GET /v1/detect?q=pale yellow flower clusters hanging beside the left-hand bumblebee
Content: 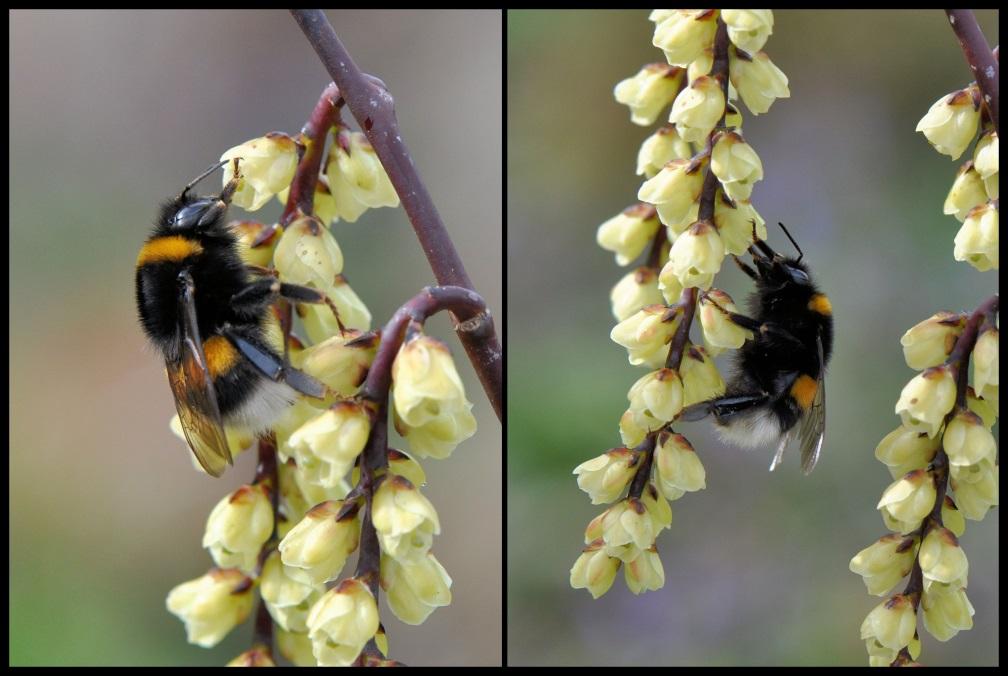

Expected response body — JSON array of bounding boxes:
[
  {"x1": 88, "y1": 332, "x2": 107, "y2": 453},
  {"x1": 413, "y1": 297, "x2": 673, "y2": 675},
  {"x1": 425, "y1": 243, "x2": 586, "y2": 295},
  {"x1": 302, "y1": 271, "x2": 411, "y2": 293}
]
[{"x1": 167, "y1": 90, "x2": 476, "y2": 666}]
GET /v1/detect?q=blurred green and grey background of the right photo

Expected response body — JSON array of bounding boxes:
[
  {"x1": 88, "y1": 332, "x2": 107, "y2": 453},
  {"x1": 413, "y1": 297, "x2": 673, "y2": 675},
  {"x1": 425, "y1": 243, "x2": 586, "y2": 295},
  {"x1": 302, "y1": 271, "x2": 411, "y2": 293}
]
[{"x1": 507, "y1": 10, "x2": 999, "y2": 665}]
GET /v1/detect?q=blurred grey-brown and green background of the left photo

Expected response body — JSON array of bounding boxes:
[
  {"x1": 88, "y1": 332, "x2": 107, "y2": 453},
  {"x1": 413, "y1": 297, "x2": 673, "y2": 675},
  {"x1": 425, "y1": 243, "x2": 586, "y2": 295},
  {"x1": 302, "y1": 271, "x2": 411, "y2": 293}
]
[{"x1": 8, "y1": 11, "x2": 504, "y2": 665}]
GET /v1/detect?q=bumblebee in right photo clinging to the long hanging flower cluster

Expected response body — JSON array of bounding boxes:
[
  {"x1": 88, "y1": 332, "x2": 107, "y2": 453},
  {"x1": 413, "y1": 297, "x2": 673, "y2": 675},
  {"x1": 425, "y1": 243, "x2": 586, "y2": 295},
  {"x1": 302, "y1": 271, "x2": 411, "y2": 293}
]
[{"x1": 680, "y1": 224, "x2": 833, "y2": 475}]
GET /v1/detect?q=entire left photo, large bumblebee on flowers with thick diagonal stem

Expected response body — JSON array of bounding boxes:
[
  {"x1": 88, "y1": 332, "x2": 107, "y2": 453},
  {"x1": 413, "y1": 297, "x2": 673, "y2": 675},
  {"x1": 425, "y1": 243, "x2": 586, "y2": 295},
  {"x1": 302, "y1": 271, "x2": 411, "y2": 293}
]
[{"x1": 8, "y1": 10, "x2": 506, "y2": 666}]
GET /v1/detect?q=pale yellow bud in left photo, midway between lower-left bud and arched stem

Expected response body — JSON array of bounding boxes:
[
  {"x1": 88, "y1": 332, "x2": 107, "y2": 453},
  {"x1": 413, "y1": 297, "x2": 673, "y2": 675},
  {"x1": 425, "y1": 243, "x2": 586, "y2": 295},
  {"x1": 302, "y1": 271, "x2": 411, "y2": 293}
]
[{"x1": 277, "y1": 501, "x2": 360, "y2": 586}]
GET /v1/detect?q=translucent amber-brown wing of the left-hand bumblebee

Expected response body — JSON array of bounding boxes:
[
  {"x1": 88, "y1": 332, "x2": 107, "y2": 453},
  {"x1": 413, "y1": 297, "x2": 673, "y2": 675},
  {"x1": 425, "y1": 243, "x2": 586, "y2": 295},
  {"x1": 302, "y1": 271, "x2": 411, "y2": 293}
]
[{"x1": 165, "y1": 275, "x2": 233, "y2": 477}]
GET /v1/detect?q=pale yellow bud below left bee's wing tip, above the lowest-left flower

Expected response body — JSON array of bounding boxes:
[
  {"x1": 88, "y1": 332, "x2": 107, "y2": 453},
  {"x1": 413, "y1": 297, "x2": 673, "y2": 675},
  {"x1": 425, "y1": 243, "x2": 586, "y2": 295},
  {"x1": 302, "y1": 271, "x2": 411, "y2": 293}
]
[{"x1": 203, "y1": 484, "x2": 273, "y2": 573}]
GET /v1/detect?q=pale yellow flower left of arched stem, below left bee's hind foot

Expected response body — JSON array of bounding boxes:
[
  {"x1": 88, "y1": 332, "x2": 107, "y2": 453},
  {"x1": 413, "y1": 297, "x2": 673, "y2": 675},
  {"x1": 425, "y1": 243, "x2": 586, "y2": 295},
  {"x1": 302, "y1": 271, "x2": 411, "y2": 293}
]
[{"x1": 289, "y1": 400, "x2": 371, "y2": 487}]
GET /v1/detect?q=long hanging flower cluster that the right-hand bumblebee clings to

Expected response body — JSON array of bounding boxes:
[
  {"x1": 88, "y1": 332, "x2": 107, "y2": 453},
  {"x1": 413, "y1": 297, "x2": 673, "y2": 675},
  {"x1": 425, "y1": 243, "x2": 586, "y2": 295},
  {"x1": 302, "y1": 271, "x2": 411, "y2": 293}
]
[{"x1": 571, "y1": 9, "x2": 790, "y2": 597}]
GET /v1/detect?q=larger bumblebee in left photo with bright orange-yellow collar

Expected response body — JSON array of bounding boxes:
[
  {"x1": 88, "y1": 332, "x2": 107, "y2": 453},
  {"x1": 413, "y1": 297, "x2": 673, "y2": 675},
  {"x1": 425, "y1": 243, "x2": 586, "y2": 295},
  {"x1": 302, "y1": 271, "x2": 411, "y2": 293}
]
[{"x1": 136, "y1": 159, "x2": 329, "y2": 477}]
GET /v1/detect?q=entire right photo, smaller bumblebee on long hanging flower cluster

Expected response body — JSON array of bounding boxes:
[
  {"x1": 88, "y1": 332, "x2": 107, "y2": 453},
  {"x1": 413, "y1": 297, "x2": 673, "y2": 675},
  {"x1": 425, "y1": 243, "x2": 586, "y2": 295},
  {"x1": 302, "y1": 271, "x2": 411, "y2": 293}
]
[{"x1": 505, "y1": 9, "x2": 1000, "y2": 666}]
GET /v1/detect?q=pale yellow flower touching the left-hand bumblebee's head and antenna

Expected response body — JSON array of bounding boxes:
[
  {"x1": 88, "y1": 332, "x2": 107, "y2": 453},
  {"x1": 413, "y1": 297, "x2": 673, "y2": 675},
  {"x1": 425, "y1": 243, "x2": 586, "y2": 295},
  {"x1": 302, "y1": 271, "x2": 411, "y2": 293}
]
[{"x1": 221, "y1": 132, "x2": 297, "y2": 212}]
